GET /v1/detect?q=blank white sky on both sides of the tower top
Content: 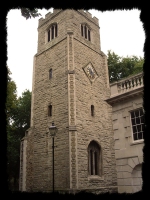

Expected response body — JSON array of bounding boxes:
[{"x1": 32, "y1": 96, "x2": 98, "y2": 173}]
[{"x1": 7, "y1": 9, "x2": 145, "y2": 96}]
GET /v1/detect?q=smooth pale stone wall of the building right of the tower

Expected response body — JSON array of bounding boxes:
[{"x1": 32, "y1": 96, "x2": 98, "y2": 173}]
[{"x1": 112, "y1": 95, "x2": 144, "y2": 193}]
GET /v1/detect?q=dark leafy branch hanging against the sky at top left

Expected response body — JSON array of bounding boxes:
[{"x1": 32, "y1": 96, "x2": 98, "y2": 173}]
[{"x1": 21, "y1": 8, "x2": 41, "y2": 19}]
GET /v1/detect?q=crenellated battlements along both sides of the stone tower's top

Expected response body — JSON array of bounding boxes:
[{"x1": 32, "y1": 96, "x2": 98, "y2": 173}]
[{"x1": 39, "y1": 9, "x2": 99, "y2": 27}]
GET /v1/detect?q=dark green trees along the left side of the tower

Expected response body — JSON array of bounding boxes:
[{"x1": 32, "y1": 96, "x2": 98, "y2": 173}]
[{"x1": 6, "y1": 66, "x2": 31, "y2": 190}]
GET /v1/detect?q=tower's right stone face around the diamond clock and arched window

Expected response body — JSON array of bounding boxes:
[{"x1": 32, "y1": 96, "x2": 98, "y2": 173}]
[{"x1": 74, "y1": 40, "x2": 117, "y2": 189}]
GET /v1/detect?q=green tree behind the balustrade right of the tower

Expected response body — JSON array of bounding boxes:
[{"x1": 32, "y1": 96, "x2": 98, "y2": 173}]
[{"x1": 107, "y1": 50, "x2": 144, "y2": 83}]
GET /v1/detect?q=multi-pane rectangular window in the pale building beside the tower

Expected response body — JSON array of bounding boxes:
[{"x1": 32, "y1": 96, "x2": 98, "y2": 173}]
[{"x1": 129, "y1": 107, "x2": 144, "y2": 142}]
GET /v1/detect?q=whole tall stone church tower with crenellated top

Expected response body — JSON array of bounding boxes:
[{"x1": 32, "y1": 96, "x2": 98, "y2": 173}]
[{"x1": 20, "y1": 9, "x2": 117, "y2": 192}]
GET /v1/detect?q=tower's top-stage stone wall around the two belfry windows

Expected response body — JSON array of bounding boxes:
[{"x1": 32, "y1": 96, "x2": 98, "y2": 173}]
[{"x1": 37, "y1": 10, "x2": 100, "y2": 53}]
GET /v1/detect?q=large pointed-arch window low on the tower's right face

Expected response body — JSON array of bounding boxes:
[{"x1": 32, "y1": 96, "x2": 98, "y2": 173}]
[{"x1": 88, "y1": 141, "x2": 102, "y2": 176}]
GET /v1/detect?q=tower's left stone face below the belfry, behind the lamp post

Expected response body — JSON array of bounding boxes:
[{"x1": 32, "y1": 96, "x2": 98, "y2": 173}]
[{"x1": 30, "y1": 36, "x2": 69, "y2": 191}]
